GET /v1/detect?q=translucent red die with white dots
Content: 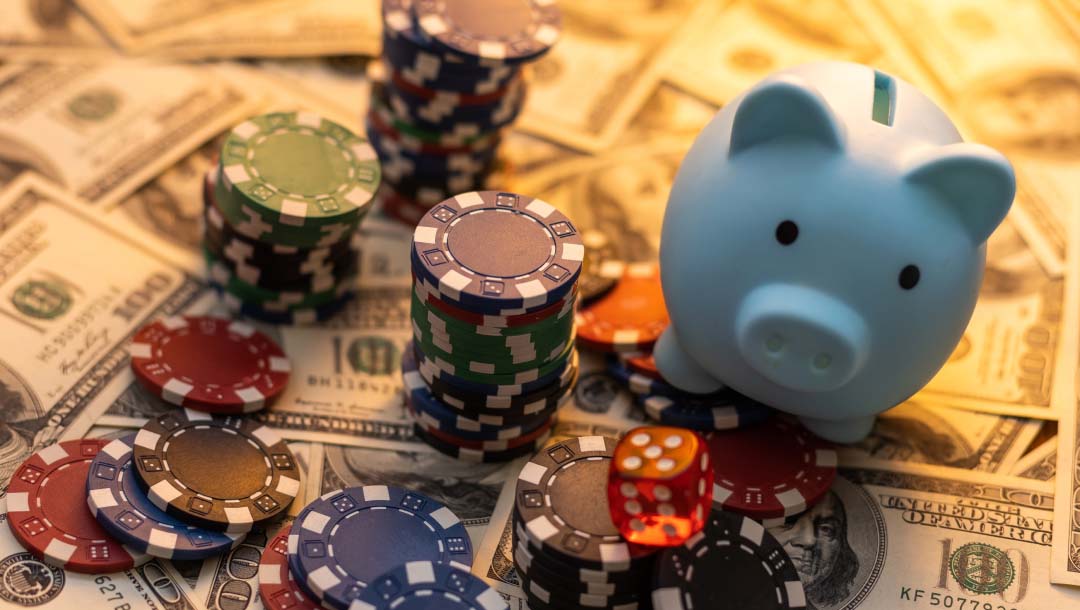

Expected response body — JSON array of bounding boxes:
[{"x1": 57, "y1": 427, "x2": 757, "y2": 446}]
[{"x1": 608, "y1": 425, "x2": 713, "y2": 546}]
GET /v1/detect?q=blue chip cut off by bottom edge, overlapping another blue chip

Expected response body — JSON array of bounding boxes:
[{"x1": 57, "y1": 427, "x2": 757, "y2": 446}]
[{"x1": 352, "y1": 561, "x2": 509, "y2": 610}]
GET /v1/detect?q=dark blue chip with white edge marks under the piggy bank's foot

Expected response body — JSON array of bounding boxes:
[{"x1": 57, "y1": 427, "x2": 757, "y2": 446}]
[{"x1": 642, "y1": 389, "x2": 774, "y2": 432}]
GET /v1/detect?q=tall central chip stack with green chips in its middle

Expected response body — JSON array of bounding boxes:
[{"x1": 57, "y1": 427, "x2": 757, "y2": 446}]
[{"x1": 402, "y1": 191, "x2": 584, "y2": 462}]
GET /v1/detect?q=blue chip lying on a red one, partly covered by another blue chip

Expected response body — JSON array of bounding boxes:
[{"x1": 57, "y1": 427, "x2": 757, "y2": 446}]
[{"x1": 288, "y1": 485, "x2": 472, "y2": 610}]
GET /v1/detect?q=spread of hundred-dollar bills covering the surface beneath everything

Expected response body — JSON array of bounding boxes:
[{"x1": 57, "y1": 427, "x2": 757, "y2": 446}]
[{"x1": 0, "y1": 0, "x2": 1080, "y2": 610}]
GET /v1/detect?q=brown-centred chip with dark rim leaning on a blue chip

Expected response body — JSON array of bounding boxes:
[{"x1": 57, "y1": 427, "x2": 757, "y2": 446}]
[{"x1": 134, "y1": 409, "x2": 300, "y2": 533}]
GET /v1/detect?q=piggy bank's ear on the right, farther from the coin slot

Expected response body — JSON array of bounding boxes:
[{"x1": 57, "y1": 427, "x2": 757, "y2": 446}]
[{"x1": 904, "y1": 143, "x2": 1016, "y2": 244}]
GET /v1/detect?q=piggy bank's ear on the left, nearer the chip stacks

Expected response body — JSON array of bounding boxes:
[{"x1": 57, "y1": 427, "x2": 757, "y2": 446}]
[{"x1": 729, "y1": 74, "x2": 843, "y2": 155}]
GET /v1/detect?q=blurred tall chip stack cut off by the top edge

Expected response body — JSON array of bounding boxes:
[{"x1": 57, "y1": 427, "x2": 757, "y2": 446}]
[{"x1": 367, "y1": 0, "x2": 562, "y2": 225}]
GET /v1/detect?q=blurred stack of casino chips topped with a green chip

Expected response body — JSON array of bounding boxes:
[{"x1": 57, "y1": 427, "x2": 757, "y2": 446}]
[{"x1": 203, "y1": 112, "x2": 380, "y2": 324}]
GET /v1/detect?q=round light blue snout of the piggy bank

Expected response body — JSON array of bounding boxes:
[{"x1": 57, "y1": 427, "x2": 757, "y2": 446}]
[{"x1": 735, "y1": 284, "x2": 869, "y2": 392}]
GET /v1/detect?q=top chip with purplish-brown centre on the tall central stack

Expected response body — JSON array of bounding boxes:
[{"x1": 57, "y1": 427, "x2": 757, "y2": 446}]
[{"x1": 413, "y1": 191, "x2": 584, "y2": 315}]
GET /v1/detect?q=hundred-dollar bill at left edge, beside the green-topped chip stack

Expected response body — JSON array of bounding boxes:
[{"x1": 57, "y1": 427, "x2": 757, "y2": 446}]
[{"x1": 0, "y1": 175, "x2": 204, "y2": 492}]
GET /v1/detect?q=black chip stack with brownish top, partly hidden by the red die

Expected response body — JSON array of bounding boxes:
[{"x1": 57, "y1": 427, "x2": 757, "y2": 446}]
[{"x1": 512, "y1": 436, "x2": 656, "y2": 610}]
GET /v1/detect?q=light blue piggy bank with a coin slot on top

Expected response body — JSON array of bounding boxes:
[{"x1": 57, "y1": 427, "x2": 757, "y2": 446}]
[{"x1": 654, "y1": 62, "x2": 1016, "y2": 443}]
